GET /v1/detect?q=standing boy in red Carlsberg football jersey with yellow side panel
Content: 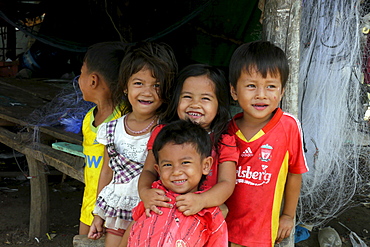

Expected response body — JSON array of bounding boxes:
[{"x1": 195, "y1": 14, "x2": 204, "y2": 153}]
[{"x1": 226, "y1": 41, "x2": 308, "y2": 247}]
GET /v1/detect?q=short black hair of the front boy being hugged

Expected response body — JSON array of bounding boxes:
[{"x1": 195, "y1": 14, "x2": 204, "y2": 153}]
[{"x1": 152, "y1": 120, "x2": 212, "y2": 164}]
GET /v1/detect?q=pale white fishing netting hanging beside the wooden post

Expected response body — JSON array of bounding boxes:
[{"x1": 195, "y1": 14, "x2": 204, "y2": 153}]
[{"x1": 298, "y1": 0, "x2": 370, "y2": 226}]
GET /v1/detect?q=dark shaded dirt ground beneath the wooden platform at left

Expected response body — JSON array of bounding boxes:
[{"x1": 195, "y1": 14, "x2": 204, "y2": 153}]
[{"x1": 0, "y1": 175, "x2": 83, "y2": 247}]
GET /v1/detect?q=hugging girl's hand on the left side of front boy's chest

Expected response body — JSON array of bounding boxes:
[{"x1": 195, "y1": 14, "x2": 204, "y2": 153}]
[{"x1": 141, "y1": 189, "x2": 173, "y2": 217}]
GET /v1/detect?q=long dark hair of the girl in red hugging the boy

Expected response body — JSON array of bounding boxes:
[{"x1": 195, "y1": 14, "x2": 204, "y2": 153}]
[{"x1": 163, "y1": 64, "x2": 231, "y2": 155}]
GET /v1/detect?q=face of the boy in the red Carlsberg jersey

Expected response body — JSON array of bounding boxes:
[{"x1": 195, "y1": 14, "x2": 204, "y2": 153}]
[{"x1": 231, "y1": 69, "x2": 284, "y2": 123}]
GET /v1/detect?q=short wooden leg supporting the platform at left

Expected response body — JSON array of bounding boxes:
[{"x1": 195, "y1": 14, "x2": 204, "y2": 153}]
[{"x1": 26, "y1": 155, "x2": 49, "y2": 239}]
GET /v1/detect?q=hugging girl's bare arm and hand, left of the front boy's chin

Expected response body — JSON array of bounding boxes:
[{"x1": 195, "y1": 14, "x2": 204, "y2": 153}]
[{"x1": 138, "y1": 150, "x2": 172, "y2": 217}]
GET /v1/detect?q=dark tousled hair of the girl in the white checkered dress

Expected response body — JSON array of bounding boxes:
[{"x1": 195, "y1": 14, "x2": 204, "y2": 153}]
[{"x1": 115, "y1": 42, "x2": 177, "y2": 116}]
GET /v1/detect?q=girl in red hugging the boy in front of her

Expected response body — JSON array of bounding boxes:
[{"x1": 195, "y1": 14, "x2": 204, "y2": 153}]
[{"x1": 139, "y1": 64, "x2": 238, "y2": 216}]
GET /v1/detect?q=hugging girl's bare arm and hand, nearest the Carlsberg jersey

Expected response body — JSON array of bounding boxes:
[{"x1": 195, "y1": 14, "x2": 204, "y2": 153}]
[{"x1": 176, "y1": 161, "x2": 236, "y2": 216}]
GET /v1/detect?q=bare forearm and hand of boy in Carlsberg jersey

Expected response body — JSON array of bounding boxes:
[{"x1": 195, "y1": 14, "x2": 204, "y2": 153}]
[{"x1": 276, "y1": 173, "x2": 302, "y2": 243}]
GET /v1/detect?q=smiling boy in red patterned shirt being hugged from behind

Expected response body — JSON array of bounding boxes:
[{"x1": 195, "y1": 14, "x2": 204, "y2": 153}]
[{"x1": 120, "y1": 120, "x2": 228, "y2": 247}]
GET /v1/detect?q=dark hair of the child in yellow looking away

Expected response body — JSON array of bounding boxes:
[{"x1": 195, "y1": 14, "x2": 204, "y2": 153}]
[{"x1": 83, "y1": 41, "x2": 129, "y2": 105}]
